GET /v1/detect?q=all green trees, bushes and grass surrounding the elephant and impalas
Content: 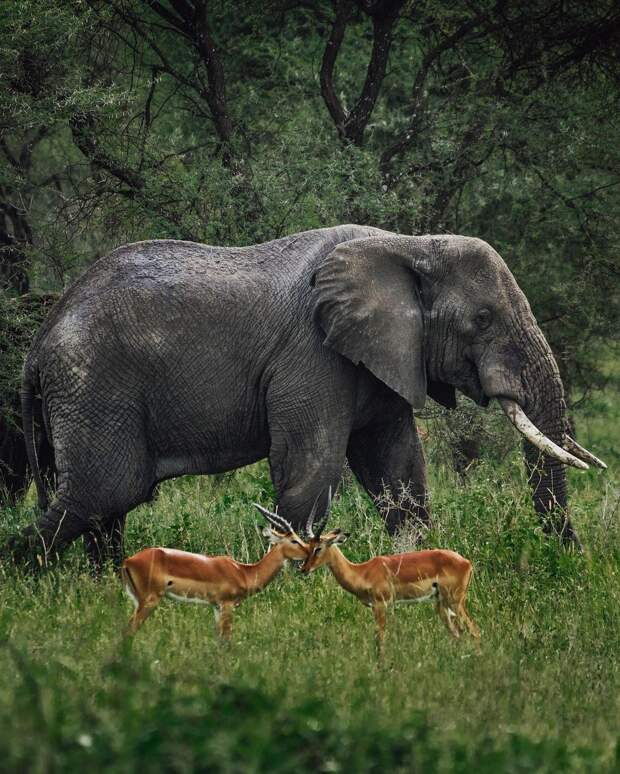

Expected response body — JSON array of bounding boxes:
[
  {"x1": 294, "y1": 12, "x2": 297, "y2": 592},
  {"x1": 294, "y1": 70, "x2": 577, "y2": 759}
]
[{"x1": 0, "y1": 0, "x2": 620, "y2": 772}]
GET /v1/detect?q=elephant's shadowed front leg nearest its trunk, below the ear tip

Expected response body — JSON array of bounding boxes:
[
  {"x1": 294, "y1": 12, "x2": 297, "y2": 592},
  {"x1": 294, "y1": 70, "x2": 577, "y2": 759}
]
[{"x1": 347, "y1": 396, "x2": 430, "y2": 534}]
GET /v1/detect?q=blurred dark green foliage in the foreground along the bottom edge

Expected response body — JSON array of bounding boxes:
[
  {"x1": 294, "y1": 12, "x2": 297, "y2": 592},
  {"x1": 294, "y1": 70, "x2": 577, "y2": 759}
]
[{"x1": 0, "y1": 660, "x2": 612, "y2": 774}]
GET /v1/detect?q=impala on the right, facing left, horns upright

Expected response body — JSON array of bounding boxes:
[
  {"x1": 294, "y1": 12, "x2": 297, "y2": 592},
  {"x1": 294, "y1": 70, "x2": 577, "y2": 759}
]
[{"x1": 301, "y1": 490, "x2": 480, "y2": 655}]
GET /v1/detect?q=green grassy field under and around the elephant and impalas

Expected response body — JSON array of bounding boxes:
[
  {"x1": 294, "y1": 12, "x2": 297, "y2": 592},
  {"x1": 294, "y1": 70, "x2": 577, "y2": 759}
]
[{"x1": 0, "y1": 396, "x2": 620, "y2": 774}]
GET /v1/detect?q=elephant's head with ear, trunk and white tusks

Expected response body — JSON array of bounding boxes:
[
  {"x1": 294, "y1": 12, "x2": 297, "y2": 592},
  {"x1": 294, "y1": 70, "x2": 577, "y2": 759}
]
[{"x1": 315, "y1": 233, "x2": 603, "y2": 536}]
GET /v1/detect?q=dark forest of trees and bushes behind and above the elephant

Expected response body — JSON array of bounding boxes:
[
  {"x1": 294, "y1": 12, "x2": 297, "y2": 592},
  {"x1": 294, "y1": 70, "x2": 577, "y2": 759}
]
[{"x1": 0, "y1": 0, "x2": 620, "y2": 498}]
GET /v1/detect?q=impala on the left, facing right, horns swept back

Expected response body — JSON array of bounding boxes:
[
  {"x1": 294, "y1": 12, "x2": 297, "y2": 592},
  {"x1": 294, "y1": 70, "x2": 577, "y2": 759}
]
[{"x1": 121, "y1": 503, "x2": 306, "y2": 640}]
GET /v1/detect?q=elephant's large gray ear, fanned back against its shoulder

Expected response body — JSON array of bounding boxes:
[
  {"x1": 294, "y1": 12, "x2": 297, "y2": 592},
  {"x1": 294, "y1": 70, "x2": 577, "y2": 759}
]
[{"x1": 314, "y1": 238, "x2": 426, "y2": 409}]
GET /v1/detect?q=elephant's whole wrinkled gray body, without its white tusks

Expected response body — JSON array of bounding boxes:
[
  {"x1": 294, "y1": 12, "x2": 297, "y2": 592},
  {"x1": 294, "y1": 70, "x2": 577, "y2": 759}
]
[{"x1": 11, "y1": 225, "x2": 573, "y2": 561}]
